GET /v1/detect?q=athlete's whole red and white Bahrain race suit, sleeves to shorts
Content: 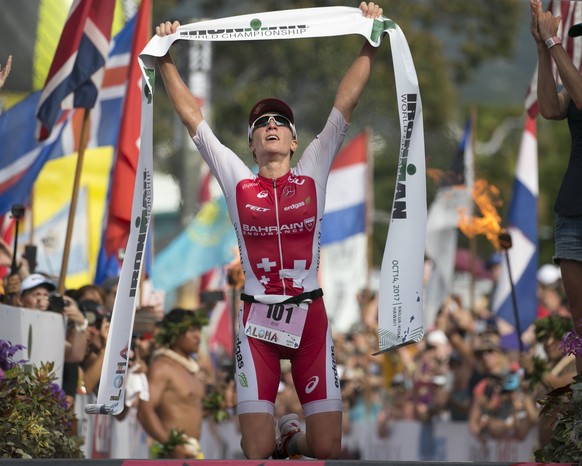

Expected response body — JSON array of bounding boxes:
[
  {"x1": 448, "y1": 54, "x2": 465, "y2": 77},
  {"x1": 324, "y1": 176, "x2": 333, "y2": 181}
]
[{"x1": 193, "y1": 108, "x2": 349, "y2": 416}]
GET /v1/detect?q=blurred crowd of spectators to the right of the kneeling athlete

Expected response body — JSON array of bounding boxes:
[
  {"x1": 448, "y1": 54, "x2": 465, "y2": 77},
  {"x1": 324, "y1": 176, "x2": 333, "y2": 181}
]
[{"x1": 336, "y1": 265, "x2": 576, "y2": 459}]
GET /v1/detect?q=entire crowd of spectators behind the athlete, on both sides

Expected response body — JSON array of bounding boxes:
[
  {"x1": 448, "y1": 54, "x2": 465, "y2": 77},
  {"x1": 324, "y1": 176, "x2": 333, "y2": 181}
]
[{"x1": 3, "y1": 256, "x2": 576, "y2": 458}]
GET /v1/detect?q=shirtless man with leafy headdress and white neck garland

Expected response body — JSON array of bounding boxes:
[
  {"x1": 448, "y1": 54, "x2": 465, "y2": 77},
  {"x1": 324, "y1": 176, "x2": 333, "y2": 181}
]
[{"x1": 138, "y1": 309, "x2": 208, "y2": 459}]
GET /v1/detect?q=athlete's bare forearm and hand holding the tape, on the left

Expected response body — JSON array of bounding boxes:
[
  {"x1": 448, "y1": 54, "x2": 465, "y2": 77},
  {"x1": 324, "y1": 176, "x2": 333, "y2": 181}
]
[{"x1": 156, "y1": 21, "x2": 204, "y2": 136}]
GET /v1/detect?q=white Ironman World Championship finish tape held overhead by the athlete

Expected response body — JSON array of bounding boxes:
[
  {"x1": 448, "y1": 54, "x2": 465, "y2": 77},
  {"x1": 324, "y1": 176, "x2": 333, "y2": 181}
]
[{"x1": 91, "y1": 7, "x2": 426, "y2": 414}]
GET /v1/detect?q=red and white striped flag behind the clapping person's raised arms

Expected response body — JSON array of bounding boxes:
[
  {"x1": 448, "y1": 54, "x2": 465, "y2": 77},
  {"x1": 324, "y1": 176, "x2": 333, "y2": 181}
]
[{"x1": 525, "y1": 0, "x2": 582, "y2": 118}]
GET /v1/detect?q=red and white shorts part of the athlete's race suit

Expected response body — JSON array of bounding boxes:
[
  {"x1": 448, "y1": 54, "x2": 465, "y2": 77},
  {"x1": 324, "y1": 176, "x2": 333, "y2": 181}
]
[{"x1": 235, "y1": 298, "x2": 342, "y2": 416}]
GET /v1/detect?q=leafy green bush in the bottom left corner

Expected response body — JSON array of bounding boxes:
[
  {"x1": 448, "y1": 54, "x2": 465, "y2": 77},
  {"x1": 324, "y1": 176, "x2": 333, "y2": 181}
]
[{"x1": 0, "y1": 340, "x2": 83, "y2": 458}]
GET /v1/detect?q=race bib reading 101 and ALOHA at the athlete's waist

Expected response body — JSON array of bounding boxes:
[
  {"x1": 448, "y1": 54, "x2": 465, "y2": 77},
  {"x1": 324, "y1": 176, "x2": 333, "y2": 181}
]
[{"x1": 245, "y1": 303, "x2": 307, "y2": 349}]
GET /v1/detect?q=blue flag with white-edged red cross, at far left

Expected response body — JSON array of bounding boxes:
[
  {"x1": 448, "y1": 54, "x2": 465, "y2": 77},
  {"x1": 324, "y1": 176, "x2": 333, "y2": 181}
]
[{"x1": 0, "y1": 18, "x2": 135, "y2": 219}]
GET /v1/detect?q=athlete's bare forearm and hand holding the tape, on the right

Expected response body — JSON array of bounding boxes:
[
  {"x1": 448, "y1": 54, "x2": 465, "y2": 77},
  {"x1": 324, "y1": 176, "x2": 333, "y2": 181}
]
[{"x1": 334, "y1": 2, "x2": 383, "y2": 121}]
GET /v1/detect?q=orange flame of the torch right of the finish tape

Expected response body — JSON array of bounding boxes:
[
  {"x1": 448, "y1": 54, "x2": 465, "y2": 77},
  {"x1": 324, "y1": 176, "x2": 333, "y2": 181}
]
[{"x1": 459, "y1": 180, "x2": 505, "y2": 250}]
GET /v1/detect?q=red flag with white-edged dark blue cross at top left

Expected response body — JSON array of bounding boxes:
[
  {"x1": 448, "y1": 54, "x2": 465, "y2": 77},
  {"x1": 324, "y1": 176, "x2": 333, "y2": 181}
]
[{"x1": 36, "y1": 0, "x2": 115, "y2": 141}]
